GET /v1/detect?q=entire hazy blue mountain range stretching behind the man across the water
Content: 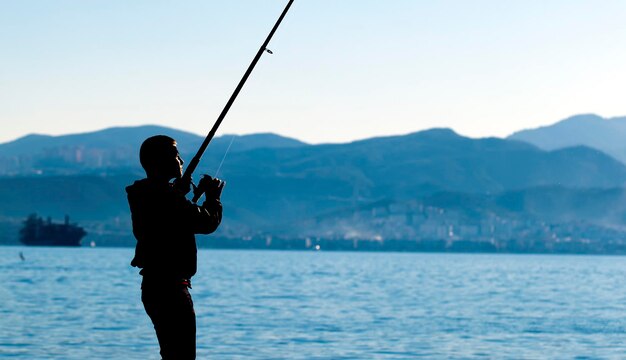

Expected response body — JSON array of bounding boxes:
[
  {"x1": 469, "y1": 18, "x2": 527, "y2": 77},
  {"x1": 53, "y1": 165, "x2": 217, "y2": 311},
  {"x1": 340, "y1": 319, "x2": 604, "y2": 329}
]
[{"x1": 0, "y1": 116, "x2": 626, "y2": 249}]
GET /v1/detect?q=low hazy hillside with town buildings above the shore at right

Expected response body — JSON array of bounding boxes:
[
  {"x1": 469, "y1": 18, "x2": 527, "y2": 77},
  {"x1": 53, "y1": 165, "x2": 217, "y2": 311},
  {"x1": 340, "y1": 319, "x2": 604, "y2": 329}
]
[{"x1": 302, "y1": 186, "x2": 626, "y2": 243}]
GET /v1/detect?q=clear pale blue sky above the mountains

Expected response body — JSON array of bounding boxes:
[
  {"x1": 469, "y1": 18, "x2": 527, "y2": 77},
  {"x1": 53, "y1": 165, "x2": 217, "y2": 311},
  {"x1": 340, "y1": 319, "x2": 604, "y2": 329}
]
[{"x1": 0, "y1": 0, "x2": 626, "y2": 143}]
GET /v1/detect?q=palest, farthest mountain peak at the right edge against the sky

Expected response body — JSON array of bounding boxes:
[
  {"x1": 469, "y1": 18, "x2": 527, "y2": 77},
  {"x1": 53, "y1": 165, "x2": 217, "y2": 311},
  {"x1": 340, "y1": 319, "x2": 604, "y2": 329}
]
[{"x1": 508, "y1": 114, "x2": 626, "y2": 163}]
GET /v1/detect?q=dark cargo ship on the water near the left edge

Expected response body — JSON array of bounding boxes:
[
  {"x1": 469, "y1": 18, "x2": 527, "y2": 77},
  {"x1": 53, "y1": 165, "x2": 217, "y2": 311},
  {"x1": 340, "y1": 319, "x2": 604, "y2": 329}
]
[{"x1": 20, "y1": 214, "x2": 87, "y2": 246}]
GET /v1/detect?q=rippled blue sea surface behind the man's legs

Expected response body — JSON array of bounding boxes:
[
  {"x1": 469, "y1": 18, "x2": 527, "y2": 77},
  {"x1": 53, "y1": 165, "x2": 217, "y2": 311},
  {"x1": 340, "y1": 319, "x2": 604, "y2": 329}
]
[{"x1": 0, "y1": 247, "x2": 626, "y2": 359}]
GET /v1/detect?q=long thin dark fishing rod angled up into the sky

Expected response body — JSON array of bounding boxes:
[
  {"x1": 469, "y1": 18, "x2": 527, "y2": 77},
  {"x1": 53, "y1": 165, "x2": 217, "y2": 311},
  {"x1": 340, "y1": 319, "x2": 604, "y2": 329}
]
[{"x1": 176, "y1": 0, "x2": 294, "y2": 202}]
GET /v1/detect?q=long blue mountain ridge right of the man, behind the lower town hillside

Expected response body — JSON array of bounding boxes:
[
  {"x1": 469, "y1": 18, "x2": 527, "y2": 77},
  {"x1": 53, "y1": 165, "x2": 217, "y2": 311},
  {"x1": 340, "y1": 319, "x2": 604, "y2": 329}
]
[{"x1": 224, "y1": 129, "x2": 626, "y2": 199}]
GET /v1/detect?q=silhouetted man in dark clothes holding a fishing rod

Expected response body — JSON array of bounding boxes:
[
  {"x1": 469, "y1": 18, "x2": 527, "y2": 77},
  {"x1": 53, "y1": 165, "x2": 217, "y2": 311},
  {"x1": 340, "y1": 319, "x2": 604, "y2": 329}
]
[{"x1": 126, "y1": 135, "x2": 224, "y2": 360}]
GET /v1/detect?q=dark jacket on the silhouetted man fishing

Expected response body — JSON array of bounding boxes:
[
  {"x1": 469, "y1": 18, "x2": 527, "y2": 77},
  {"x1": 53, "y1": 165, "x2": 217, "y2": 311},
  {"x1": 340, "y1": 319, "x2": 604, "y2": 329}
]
[{"x1": 126, "y1": 179, "x2": 222, "y2": 279}]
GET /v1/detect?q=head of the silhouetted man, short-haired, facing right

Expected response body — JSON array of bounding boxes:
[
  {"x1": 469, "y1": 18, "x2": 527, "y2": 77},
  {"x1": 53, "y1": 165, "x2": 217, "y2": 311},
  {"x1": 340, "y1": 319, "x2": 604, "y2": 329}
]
[{"x1": 139, "y1": 135, "x2": 183, "y2": 181}]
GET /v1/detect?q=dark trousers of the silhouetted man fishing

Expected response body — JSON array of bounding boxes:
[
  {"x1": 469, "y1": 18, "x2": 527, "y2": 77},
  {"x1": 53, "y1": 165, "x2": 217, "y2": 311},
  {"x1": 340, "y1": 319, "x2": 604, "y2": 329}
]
[{"x1": 141, "y1": 278, "x2": 196, "y2": 360}]
